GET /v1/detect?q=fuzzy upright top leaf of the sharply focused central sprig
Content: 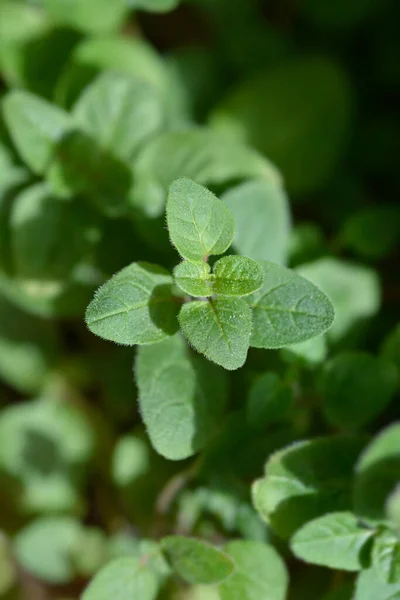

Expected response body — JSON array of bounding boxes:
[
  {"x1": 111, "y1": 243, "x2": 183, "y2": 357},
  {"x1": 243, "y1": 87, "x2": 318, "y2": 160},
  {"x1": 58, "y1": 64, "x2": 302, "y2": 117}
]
[{"x1": 167, "y1": 179, "x2": 235, "y2": 261}]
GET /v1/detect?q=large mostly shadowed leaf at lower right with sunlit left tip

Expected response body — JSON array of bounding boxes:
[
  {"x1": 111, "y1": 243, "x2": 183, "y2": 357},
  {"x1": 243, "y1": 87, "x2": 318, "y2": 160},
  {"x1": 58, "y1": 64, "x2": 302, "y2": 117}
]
[{"x1": 253, "y1": 437, "x2": 363, "y2": 539}]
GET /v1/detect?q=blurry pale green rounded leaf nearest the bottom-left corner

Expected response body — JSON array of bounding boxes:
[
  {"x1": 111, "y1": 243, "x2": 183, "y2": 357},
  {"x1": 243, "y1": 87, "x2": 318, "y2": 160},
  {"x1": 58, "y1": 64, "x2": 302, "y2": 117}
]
[{"x1": 14, "y1": 517, "x2": 81, "y2": 585}]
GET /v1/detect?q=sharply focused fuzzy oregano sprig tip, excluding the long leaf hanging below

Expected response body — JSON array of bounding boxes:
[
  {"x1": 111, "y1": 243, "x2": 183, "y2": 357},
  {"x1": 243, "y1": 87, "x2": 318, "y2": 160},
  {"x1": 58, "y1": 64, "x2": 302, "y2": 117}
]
[{"x1": 86, "y1": 179, "x2": 334, "y2": 370}]
